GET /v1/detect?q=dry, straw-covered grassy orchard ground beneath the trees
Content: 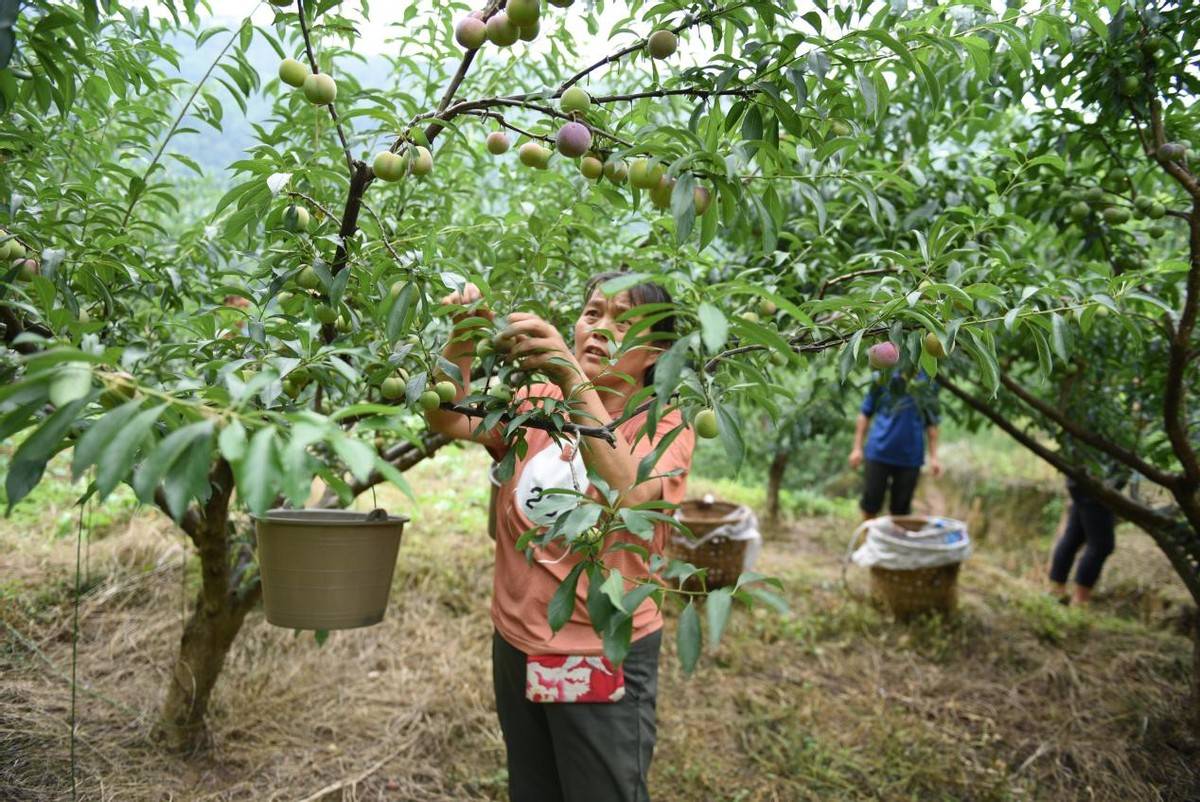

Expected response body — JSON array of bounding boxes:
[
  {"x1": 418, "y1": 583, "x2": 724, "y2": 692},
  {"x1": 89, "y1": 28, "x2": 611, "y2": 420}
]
[{"x1": 0, "y1": 437, "x2": 1200, "y2": 802}]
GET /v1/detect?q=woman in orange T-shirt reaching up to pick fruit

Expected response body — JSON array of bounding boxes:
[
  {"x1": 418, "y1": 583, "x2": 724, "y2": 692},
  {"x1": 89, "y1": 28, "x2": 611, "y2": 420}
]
[{"x1": 426, "y1": 273, "x2": 695, "y2": 802}]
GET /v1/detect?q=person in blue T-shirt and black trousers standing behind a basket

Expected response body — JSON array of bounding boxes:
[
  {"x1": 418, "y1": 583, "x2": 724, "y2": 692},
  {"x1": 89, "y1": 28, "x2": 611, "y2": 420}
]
[{"x1": 850, "y1": 372, "x2": 942, "y2": 519}]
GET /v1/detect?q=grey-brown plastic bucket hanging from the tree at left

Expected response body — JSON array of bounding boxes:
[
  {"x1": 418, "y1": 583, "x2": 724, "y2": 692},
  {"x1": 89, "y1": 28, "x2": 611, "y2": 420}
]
[{"x1": 254, "y1": 509, "x2": 408, "y2": 629}]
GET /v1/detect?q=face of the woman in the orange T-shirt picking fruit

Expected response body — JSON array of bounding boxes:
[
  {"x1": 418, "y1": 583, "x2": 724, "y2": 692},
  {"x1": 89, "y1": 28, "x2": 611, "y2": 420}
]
[{"x1": 575, "y1": 289, "x2": 659, "y2": 387}]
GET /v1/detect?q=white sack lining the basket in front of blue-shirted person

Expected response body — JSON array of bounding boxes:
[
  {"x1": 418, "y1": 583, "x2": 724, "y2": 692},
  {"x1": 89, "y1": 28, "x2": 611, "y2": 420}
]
[{"x1": 851, "y1": 515, "x2": 971, "y2": 570}]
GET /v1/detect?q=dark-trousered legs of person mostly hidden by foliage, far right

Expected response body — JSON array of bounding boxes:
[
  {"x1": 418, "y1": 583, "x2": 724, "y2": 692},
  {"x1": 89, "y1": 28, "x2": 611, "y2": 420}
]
[{"x1": 1050, "y1": 479, "x2": 1116, "y2": 605}]
